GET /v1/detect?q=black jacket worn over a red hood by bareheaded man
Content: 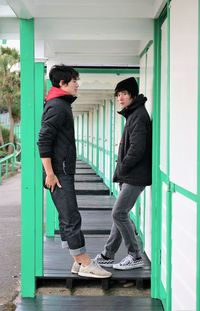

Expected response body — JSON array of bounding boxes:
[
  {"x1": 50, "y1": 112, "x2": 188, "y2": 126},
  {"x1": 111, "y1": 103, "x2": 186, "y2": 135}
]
[{"x1": 38, "y1": 95, "x2": 76, "y2": 174}]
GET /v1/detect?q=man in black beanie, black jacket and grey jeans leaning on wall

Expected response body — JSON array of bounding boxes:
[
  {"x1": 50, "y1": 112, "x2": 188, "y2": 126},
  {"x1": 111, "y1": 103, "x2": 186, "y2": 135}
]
[{"x1": 95, "y1": 78, "x2": 152, "y2": 270}]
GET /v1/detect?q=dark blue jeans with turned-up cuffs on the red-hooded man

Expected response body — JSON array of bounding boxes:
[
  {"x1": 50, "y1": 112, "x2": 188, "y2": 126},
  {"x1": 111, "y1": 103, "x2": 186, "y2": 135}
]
[{"x1": 51, "y1": 174, "x2": 86, "y2": 256}]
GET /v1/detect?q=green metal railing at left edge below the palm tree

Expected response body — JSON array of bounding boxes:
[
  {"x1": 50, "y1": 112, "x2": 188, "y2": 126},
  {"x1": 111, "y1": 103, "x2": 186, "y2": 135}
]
[{"x1": 0, "y1": 143, "x2": 16, "y2": 185}]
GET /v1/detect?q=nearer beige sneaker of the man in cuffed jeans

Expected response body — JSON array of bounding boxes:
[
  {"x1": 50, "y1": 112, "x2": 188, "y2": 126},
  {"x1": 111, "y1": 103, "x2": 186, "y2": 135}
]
[{"x1": 78, "y1": 260, "x2": 112, "y2": 279}]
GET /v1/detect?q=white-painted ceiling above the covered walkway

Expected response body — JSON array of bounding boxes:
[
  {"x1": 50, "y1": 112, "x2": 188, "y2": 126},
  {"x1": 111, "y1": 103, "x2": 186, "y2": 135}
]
[{"x1": 0, "y1": 0, "x2": 166, "y2": 112}]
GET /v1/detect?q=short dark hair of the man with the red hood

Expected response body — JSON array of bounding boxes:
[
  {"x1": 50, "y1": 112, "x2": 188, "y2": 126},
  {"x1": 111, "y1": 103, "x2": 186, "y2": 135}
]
[{"x1": 49, "y1": 65, "x2": 79, "y2": 88}]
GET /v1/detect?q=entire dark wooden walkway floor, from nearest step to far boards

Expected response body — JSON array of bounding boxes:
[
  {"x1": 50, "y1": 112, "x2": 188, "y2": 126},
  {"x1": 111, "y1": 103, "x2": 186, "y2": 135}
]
[{"x1": 16, "y1": 161, "x2": 163, "y2": 311}]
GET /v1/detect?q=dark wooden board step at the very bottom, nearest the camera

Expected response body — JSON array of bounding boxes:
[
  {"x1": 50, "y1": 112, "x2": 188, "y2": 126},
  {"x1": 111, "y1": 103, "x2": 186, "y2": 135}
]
[{"x1": 16, "y1": 296, "x2": 163, "y2": 311}]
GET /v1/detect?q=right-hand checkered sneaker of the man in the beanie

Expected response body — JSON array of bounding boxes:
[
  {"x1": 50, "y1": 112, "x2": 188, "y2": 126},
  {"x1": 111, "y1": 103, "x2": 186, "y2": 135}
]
[{"x1": 113, "y1": 255, "x2": 144, "y2": 270}]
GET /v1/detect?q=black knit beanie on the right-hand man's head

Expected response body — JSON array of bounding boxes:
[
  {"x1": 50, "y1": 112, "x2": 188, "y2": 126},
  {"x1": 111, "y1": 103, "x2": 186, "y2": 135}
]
[{"x1": 115, "y1": 77, "x2": 139, "y2": 98}]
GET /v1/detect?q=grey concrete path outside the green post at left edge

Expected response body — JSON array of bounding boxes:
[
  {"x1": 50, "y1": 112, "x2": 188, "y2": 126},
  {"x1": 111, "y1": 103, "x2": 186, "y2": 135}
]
[{"x1": 0, "y1": 173, "x2": 21, "y2": 310}]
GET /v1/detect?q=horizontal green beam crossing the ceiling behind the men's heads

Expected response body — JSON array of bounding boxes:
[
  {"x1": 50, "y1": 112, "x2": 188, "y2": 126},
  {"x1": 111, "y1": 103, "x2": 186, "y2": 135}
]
[{"x1": 74, "y1": 66, "x2": 140, "y2": 75}]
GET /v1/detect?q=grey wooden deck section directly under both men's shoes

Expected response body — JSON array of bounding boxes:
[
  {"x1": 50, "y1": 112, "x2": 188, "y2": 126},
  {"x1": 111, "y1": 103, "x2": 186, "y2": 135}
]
[{"x1": 42, "y1": 235, "x2": 151, "y2": 280}]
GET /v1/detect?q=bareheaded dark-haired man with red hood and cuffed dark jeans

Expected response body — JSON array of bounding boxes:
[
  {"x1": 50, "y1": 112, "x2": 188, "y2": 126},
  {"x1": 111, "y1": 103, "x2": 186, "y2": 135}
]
[{"x1": 38, "y1": 65, "x2": 111, "y2": 278}]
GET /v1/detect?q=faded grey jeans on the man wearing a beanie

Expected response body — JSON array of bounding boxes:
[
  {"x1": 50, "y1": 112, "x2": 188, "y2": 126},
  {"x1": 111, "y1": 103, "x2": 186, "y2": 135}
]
[{"x1": 102, "y1": 183, "x2": 145, "y2": 259}]
